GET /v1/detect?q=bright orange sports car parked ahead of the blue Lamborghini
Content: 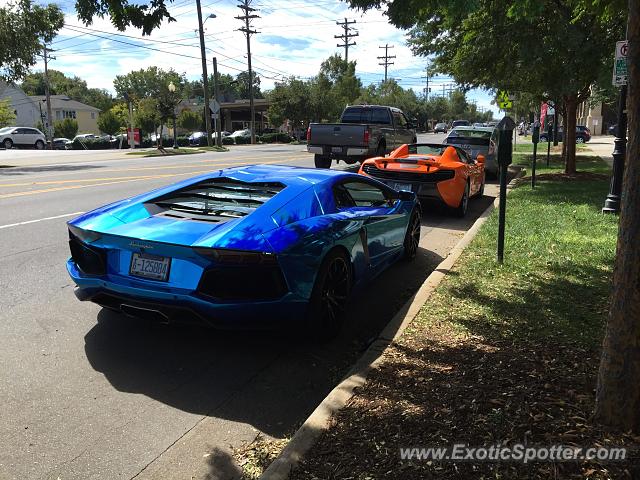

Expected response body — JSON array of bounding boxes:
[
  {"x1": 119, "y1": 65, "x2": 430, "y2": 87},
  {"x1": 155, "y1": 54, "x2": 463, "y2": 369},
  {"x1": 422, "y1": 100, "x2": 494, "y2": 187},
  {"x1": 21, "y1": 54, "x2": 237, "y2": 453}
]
[{"x1": 359, "y1": 143, "x2": 485, "y2": 217}]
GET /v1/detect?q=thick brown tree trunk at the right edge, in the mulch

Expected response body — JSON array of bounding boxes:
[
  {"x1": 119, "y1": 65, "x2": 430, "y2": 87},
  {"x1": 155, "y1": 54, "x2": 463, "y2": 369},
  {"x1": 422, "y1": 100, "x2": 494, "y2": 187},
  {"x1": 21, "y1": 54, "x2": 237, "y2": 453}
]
[{"x1": 595, "y1": 0, "x2": 640, "y2": 433}]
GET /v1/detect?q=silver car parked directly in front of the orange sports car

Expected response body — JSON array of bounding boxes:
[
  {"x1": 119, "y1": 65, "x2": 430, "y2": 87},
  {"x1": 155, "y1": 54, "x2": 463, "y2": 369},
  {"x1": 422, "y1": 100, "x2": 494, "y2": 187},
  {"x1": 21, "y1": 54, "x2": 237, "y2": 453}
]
[{"x1": 442, "y1": 127, "x2": 498, "y2": 178}]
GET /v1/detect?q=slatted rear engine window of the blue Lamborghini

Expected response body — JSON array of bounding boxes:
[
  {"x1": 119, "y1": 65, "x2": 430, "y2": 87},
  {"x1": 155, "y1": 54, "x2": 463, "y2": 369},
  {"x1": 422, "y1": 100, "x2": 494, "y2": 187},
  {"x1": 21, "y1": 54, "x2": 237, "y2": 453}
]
[{"x1": 151, "y1": 178, "x2": 285, "y2": 220}]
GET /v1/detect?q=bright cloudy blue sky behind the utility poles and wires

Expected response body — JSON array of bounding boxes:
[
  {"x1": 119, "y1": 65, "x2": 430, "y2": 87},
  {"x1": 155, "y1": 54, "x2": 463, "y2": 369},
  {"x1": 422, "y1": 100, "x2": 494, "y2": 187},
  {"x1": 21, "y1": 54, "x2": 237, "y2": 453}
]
[{"x1": 15, "y1": 0, "x2": 497, "y2": 116}]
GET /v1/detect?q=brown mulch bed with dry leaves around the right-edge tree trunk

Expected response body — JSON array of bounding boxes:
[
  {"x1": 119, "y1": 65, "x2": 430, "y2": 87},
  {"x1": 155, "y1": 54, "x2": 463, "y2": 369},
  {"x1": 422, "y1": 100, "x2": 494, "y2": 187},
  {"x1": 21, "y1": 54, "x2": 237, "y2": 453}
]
[{"x1": 291, "y1": 318, "x2": 640, "y2": 480}]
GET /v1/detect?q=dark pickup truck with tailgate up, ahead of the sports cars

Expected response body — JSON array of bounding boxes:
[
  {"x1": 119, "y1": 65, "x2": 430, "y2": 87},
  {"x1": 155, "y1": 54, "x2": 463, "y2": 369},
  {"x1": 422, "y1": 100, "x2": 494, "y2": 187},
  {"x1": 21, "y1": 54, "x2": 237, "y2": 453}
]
[{"x1": 307, "y1": 105, "x2": 416, "y2": 168}]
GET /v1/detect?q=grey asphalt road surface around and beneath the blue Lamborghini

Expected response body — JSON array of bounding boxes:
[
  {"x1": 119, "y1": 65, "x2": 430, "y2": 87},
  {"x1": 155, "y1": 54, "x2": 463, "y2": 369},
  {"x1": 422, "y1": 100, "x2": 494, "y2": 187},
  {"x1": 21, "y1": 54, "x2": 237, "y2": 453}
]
[{"x1": 0, "y1": 135, "x2": 496, "y2": 480}]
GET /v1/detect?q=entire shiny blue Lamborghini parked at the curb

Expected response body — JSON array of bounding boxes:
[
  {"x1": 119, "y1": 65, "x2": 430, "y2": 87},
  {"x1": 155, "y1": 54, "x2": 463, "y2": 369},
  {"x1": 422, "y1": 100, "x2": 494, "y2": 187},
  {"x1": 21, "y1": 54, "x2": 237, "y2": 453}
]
[{"x1": 67, "y1": 165, "x2": 420, "y2": 337}]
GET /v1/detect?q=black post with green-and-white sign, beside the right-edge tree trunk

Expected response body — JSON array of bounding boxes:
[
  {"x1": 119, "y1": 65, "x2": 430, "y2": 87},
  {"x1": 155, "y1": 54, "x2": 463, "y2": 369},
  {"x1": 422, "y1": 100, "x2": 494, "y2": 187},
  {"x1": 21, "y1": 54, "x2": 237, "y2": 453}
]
[{"x1": 602, "y1": 40, "x2": 629, "y2": 213}]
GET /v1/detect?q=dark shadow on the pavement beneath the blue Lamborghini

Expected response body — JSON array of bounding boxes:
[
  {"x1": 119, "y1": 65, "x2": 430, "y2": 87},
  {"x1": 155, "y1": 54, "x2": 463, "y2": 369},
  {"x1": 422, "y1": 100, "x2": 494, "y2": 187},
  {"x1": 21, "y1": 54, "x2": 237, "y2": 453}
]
[{"x1": 85, "y1": 244, "x2": 442, "y2": 438}]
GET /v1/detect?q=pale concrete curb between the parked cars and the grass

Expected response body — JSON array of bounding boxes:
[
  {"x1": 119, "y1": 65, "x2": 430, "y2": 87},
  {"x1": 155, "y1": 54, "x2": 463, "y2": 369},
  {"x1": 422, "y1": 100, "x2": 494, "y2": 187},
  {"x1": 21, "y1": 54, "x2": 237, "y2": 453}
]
[{"x1": 259, "y1": 169, "x2": 524, "y2": 480}]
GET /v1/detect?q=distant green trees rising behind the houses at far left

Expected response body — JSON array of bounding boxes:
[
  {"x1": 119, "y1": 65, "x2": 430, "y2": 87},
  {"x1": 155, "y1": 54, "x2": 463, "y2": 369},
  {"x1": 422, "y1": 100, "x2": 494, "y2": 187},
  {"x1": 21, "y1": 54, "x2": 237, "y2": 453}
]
[{"x1": 20, "y1": 70, "x2": 114, "y2": 112}]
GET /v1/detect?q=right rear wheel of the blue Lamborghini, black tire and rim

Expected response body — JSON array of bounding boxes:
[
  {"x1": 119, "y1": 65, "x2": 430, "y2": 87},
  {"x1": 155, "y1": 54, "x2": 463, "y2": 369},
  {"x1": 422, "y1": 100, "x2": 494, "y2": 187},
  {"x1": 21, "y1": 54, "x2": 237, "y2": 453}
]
[{"x1": 307, "y1": 250, "x2": 351, "y2": 342}]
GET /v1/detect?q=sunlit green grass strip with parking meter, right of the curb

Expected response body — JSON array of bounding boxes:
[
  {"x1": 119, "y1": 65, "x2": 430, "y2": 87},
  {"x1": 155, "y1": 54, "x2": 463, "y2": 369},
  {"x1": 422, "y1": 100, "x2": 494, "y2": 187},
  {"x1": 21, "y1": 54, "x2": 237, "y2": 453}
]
[{"x1": 412, "y1": 157, "x2": 618, "y2": 347}]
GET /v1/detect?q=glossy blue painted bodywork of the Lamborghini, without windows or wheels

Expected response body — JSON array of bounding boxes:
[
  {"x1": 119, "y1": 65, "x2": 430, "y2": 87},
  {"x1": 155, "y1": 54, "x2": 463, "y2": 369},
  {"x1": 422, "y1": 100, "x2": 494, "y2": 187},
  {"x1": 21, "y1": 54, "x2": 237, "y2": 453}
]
[{"x1": 67, "y1": 165, "x2": 417, "y2": 325}]
